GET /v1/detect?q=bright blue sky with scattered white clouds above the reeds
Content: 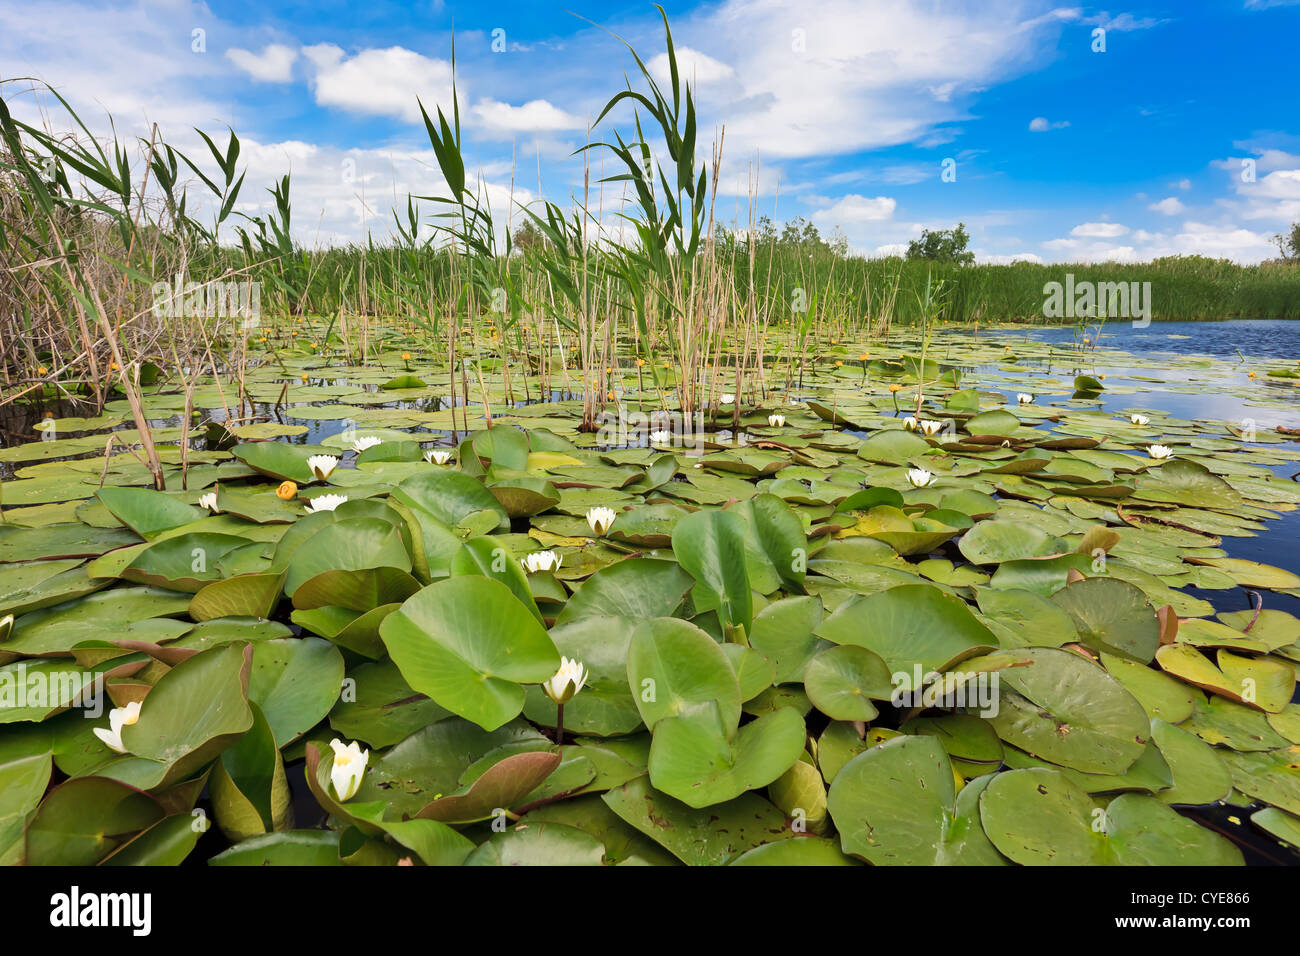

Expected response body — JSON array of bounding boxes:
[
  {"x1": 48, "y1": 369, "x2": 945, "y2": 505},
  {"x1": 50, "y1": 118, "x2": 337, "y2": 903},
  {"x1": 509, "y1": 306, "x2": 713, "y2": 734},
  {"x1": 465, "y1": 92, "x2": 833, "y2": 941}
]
[{"x1": 0, "y1": 0, "x2": 1300, "y2": 261}]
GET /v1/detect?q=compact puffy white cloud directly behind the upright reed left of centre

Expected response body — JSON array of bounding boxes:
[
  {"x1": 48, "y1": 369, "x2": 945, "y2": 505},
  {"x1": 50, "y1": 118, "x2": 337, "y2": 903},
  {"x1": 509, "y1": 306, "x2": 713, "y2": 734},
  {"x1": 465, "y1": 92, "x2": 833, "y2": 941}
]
[{"x1": 303, "y1": 43, "x2": 465, "y2": 124}]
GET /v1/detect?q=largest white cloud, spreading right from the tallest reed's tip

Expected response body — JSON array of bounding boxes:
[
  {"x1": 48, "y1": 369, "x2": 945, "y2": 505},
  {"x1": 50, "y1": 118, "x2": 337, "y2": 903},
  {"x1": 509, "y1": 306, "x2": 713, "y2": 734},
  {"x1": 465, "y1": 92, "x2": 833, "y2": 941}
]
[{"x1": 655, "y1": 0, "x2": 1078, "y2": 159}]
